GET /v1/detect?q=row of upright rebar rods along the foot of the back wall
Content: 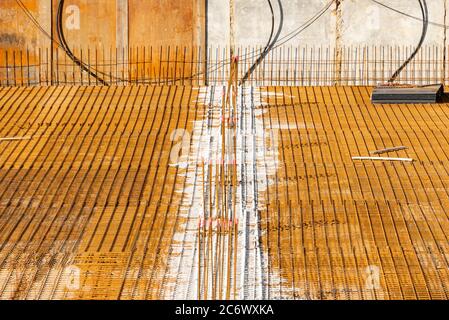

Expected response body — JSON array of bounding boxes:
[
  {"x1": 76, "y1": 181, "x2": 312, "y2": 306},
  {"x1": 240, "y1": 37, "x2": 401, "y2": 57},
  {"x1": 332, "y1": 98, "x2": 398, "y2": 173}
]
[{"x1": 0, "y1": 46, "x2": 449, "y2": 86}]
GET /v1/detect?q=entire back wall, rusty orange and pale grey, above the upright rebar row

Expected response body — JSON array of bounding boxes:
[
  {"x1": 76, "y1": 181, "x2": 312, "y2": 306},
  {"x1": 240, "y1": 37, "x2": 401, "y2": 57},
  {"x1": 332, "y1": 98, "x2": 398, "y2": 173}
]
[{"x1": 0, "y1": 0, "x2": 448, "y2": 48}]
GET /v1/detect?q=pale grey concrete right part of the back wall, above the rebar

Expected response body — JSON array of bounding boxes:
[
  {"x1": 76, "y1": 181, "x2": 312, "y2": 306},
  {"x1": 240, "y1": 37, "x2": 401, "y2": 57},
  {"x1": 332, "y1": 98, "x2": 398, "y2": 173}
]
[{"x1": 208, "y1": 0, "x2": 448, "y2": 46}]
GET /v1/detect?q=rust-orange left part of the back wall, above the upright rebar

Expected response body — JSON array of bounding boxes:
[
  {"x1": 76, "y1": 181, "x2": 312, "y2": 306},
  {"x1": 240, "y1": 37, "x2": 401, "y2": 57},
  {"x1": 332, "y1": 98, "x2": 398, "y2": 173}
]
[{"x1": 0, "y1": 0, "x2": 205, "y2": 49}]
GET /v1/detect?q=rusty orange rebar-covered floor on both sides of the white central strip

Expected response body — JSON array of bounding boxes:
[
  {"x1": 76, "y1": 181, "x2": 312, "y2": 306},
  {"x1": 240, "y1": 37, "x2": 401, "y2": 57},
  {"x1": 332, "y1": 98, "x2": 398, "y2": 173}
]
[{"x1": 0, "y1": 86, "x2": 449, "y2": 299}]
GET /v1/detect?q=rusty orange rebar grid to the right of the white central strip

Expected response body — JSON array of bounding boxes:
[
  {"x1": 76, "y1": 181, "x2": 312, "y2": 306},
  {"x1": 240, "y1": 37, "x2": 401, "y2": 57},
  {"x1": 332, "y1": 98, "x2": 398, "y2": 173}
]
[{"x1": 261, "y1": 87, "x2": 449, "y2": 299}]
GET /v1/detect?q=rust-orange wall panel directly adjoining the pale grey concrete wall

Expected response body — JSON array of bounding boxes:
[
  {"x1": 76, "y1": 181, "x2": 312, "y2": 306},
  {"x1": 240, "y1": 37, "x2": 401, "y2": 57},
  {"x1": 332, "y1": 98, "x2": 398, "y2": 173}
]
[{"x1": 128, "y1": 0, "x2": 206, "y2": 78}]
